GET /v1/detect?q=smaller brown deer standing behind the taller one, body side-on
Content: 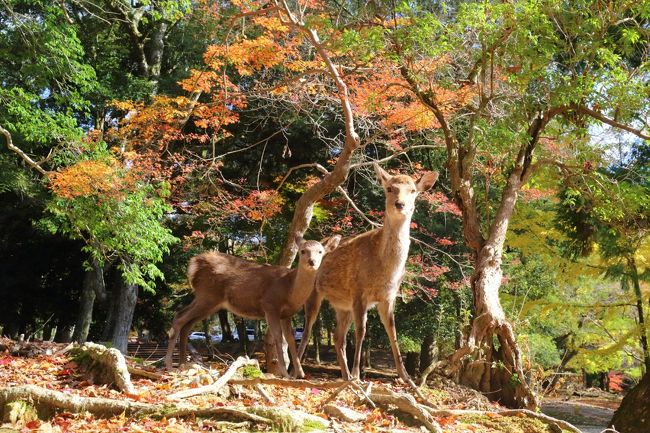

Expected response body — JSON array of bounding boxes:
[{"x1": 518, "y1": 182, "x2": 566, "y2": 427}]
[{"x1": 165, "y1": 235, "x2": 341, "y2": 378}]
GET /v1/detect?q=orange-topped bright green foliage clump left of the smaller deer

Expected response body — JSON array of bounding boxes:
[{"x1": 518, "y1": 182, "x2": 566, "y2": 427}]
[{"x1": 40, "y1": 145, "x2": 176, "y2": 290}]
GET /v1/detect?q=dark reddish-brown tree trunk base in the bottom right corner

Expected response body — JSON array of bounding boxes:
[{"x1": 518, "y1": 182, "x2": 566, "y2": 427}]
[{"x1": 611, "y1": 370, "x2": 650, "y2": 433}]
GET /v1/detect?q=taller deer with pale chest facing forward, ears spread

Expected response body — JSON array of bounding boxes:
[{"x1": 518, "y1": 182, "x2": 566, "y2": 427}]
[{"x1": 298, "y1": 164, "x2": 438, "y2": 383}]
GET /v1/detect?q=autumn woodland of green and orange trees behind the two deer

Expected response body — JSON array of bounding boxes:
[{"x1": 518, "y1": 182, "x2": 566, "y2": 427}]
[{"x1": 0, "y1": 0, "x2": 650, "y2": 420}]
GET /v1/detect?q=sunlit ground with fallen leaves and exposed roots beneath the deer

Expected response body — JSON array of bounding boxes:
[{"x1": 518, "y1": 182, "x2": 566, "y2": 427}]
[{"x1": 0, "y1": 339, "x2": 611, "y2": 433}]
